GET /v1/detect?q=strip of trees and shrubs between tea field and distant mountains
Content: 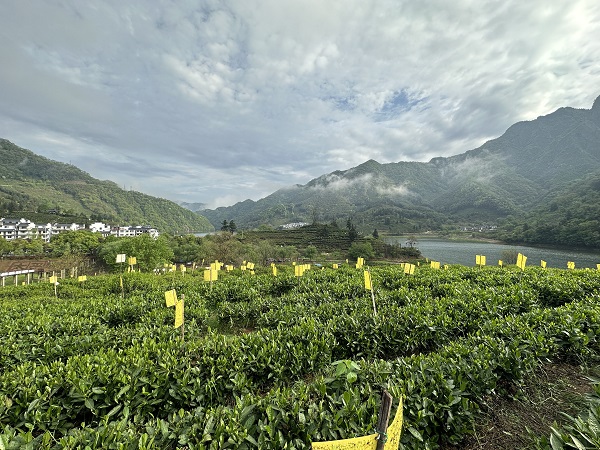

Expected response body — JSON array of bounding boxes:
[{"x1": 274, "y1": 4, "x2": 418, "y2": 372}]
[{"x1": 0, "y1": 224, "x2": 421, "y2": 271}]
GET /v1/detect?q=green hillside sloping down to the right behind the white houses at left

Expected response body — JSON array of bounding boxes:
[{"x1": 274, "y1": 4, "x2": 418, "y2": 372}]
[{"x1": 0, "y1": 139, "x2": 213, "y2": 232}]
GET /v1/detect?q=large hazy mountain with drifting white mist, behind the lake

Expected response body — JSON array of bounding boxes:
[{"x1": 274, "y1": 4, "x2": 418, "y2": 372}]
[{"x1": 199, "y1": 97, "x2": 600, "y2": 241}]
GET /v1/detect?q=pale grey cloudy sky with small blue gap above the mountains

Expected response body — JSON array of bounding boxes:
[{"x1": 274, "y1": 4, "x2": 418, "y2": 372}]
[{"x1": 0, "y1": 0, "x2": 600, "y2": 207}]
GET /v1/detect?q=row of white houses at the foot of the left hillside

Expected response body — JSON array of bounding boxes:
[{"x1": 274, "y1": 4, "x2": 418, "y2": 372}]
[{"x1": 0, "y1": 217, "x2": 158, "y2": 242}]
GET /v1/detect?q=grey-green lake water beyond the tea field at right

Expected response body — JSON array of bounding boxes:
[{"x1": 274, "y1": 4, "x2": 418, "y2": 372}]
[{"x1": 386, "y1": 236, "x2": 600, "y2": 269}]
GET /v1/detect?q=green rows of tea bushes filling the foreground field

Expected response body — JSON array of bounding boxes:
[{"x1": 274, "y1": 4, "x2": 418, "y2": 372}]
[{"x1": 0, "y1": 266, "x2": 600, "y2": 449}]
